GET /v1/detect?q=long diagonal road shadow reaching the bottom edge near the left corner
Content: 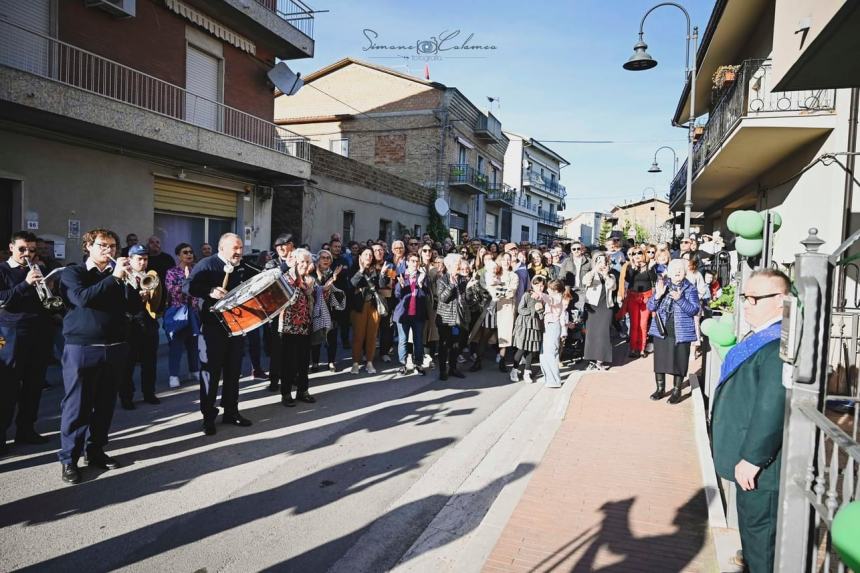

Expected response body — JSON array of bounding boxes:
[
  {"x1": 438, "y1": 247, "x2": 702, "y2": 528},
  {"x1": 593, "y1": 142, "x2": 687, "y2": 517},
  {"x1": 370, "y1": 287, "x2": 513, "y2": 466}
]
[{"x1": 16, "y1": 438, "x2": 454, "y2": 571}]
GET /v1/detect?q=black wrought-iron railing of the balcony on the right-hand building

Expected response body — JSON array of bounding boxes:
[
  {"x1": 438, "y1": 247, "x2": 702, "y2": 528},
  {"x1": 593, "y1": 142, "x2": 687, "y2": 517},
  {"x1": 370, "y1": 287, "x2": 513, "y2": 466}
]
[{"x1": 670, "y1": 59, "x2": 836, "y2": 203}]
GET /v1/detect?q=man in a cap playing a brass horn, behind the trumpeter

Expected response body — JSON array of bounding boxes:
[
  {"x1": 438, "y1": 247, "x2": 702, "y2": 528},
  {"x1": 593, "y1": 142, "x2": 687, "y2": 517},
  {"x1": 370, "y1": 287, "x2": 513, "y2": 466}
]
[{"x1": 119, "y1": 245, "x2": 162, "y2": 410}]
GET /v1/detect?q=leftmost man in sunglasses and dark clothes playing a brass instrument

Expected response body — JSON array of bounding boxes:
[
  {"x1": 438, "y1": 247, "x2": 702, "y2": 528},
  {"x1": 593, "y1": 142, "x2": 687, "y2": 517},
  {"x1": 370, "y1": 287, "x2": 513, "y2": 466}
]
[{"x1": 0, "y1": 231, "x2": 51, "y2": 455}]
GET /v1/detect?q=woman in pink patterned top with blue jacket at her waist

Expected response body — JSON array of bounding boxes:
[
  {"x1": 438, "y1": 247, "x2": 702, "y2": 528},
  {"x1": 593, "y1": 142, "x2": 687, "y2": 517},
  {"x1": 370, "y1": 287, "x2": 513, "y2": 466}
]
[{"x1": 163, "y1": 243, "x2": 200, "y2": 388}]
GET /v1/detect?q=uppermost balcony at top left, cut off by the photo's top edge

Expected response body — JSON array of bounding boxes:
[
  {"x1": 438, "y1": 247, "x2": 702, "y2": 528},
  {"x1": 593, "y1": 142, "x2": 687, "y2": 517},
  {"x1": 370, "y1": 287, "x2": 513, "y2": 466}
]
[{"x1": 181, "y1": 0, "x2": 314, "y2": 60}]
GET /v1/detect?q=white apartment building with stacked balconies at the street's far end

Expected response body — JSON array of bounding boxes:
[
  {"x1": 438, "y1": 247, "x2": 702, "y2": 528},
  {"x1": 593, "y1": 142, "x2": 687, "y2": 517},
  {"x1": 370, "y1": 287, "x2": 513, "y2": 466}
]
[{"x1": 504, "y1": 132, "x2": 570, "y2": 244}]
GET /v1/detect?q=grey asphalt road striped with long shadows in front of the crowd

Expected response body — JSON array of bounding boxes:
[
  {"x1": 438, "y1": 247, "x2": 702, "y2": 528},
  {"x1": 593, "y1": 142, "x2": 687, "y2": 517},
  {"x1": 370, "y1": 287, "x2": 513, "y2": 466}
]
[{"x1": 0, "y1": 342, "x2": 558, "y2": 572}]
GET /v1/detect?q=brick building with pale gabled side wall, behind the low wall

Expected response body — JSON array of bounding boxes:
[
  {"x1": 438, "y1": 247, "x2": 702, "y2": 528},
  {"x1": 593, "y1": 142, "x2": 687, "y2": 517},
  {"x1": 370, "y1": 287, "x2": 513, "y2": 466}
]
[{"x1": 275, "y1": 58, "x2": 512, "y2": 244}]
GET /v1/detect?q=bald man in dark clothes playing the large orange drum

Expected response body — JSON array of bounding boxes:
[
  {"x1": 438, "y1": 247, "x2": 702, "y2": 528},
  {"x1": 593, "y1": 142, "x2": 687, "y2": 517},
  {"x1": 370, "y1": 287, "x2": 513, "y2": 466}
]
[{"x1": 182, "y1": 233, "x2": 253, "y2": 436}]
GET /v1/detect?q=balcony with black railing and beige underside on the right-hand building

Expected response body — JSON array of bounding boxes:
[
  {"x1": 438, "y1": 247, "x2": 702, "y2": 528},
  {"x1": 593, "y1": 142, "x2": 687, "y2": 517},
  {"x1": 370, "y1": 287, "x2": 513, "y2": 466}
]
[{"x1": 669, "y1": 60, "x2": 836, "y2": 212}]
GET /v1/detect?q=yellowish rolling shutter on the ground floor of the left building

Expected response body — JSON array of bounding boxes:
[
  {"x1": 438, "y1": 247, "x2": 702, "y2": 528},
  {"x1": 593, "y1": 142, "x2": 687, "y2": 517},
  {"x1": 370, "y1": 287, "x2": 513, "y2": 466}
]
[{"x1": 155, "y1": 177, "x2": 238, "y2": 219}]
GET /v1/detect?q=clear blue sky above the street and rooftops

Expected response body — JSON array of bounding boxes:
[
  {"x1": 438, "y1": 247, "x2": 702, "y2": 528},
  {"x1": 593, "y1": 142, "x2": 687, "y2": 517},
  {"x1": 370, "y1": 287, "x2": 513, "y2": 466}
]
[{"x1": 290, "y1": 0, "x2": 714, "y2": 215}]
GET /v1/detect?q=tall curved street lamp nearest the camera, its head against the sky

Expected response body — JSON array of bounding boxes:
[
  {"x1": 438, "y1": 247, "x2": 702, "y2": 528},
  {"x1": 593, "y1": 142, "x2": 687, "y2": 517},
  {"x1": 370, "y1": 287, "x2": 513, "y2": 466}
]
[{"x1": 624, "y1": 2, "x2": 699, "y2": 235}]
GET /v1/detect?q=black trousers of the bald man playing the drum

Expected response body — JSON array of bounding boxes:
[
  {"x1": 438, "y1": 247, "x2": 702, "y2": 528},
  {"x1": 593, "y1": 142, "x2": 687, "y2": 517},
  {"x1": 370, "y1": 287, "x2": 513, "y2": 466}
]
[{"x1": 198, "y1": 323, "x2": 245, "y2": 421}]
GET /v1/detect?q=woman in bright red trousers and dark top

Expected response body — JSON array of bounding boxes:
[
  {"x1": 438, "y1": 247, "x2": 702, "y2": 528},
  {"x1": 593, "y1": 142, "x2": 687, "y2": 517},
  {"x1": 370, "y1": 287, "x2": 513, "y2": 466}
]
[{"x1": 615, "y1": 246, "x2": 658, "y2": 358}]
